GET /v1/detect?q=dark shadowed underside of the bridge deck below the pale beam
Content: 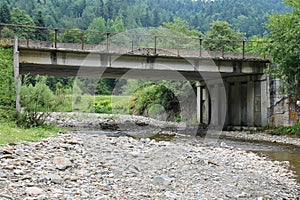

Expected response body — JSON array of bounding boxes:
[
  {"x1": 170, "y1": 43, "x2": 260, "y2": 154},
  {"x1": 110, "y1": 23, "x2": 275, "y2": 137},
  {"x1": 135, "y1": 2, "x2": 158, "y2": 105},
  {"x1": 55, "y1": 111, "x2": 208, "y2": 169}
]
[{"x1": 20, "y1": 63, "x2": 261, "y2": 81}]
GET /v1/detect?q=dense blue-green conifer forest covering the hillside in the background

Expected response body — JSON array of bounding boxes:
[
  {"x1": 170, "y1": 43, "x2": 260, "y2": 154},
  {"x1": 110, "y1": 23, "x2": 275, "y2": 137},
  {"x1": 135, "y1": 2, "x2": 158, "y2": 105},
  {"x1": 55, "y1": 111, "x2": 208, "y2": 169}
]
[{"x1": 0, "y1": 0, "x2": 290, "y2": 37}]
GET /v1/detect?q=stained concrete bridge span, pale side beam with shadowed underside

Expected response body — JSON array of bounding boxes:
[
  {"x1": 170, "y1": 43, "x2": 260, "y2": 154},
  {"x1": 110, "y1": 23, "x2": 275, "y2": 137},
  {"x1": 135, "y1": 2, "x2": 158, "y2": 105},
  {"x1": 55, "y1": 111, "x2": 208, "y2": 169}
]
[{"x1": 19, "y1": 47, "x2": 268, "y2": 80}]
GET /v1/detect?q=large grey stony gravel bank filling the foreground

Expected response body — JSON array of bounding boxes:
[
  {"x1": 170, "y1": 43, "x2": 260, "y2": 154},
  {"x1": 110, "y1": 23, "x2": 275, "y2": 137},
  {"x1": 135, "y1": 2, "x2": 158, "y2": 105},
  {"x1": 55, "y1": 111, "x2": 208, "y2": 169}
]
[{"x1": 0, "y1": 132, "x2": 300, "y2": 200}]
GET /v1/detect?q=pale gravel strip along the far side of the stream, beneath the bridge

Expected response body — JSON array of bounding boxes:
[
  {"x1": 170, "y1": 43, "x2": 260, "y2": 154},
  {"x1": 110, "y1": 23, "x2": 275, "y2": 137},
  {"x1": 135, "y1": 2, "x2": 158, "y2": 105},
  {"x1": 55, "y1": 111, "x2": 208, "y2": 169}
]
[{"x1": 49, "y1": 113, "x2": 300, "y2": 146}]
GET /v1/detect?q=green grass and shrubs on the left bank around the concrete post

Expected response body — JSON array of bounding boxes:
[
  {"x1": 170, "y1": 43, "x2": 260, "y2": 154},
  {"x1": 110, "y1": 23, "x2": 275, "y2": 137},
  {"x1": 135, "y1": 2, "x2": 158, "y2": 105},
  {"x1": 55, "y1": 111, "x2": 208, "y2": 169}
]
[{"x1": 0, "y1": 48, "x2": 62, "y2": 145}]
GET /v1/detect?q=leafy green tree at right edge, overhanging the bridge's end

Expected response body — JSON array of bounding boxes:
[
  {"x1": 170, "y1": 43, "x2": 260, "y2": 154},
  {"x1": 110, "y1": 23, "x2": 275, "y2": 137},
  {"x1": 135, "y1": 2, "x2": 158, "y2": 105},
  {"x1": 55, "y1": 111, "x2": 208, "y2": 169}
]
[{"x1": 267, "y1": 0, "x2": 300, "y2": 98}]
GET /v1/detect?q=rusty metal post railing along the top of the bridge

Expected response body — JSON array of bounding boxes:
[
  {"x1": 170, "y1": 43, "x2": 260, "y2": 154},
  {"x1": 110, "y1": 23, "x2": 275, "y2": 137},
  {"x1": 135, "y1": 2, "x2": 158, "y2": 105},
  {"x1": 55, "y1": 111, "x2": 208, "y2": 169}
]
[{"x1": 0, "y1": 24, "x2": 266, "y2": 59}]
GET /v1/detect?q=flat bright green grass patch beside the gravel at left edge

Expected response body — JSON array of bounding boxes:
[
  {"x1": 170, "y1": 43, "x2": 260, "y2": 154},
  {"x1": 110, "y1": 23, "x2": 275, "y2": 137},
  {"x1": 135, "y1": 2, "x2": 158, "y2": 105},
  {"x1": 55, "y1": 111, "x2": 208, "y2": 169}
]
[{"x1": 0, "y1": 121, "x2": 64, "y2": 145}]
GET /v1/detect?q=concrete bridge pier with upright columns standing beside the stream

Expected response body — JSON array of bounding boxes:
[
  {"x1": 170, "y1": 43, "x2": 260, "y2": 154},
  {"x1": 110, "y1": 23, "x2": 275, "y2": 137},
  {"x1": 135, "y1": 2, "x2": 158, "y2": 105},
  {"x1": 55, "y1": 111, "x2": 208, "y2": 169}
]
[{"x1": 197, "y1": 75, "x2": 269, "y2": 129}]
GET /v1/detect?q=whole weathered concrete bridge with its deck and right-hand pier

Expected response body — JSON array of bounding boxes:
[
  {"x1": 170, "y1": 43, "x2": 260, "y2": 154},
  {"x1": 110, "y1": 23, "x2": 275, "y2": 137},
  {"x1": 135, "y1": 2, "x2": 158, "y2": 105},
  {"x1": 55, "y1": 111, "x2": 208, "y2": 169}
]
[{"x1": 6, "y1": 24, "x2": 269, "y2": 127}]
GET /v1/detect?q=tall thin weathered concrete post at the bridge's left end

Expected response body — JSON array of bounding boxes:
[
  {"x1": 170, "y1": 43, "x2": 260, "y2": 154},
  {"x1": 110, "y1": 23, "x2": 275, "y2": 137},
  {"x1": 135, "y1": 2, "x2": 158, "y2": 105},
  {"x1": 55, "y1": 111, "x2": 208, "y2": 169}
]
[{"x1": 14, "y1": 37, "x2": 21, "y2": 113}]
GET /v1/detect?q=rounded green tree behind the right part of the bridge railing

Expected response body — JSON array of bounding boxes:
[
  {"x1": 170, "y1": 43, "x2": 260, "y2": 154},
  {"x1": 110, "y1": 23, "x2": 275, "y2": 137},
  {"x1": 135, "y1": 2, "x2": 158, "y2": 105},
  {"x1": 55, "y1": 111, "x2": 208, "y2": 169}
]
[{"x1": 204, "y1": 21, "x2": 245, "y2": 52}]
